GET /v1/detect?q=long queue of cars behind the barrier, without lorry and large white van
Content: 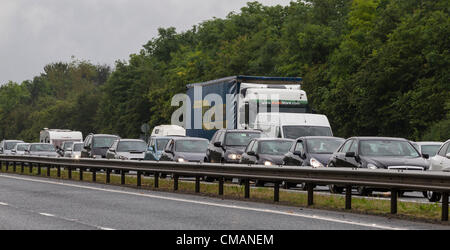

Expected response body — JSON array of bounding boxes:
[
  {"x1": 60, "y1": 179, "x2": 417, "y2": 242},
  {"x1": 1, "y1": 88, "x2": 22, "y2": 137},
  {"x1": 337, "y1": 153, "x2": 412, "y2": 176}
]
[{"x1": 0, "y1": 125, "x2": 450, "y2": 202}]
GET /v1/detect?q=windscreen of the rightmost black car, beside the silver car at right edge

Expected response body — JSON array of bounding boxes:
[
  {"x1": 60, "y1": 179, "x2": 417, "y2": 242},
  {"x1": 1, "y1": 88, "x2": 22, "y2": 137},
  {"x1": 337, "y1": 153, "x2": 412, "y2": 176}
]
[{"x1": 359, "y1": 140, "x2": 420, "y2": 157}]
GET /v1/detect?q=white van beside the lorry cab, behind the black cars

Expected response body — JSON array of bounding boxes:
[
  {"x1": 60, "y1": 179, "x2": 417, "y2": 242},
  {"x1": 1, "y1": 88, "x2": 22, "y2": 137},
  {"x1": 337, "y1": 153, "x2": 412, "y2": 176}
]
[{"x1": 251, "y1": 113, "x2": 333, "y2": 139}]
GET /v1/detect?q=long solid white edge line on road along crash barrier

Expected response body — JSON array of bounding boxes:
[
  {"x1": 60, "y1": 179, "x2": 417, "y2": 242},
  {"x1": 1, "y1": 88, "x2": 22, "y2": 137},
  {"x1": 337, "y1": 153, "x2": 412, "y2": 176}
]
[{"x1": 0, "y1": 174, "x2": 407, "y2": 230}]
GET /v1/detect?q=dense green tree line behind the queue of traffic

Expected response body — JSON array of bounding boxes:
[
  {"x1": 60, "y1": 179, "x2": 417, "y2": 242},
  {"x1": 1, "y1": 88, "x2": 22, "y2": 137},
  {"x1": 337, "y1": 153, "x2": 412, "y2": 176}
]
[{"x1": 0, "y1": 0, "x2": 450, "y2": 141}]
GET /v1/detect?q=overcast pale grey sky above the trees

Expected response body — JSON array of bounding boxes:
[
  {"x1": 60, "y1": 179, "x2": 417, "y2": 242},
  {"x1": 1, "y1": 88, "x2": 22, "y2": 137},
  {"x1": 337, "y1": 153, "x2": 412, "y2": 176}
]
[{"x1": 0, "y1": 0, "x2": 291, "y2": 84}]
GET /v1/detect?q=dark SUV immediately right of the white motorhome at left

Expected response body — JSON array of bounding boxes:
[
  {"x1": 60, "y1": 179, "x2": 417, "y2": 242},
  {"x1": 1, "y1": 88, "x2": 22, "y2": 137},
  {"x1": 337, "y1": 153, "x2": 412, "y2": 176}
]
[{"x1": 81, "y1": 134, "x2": 120, "y2": 158}]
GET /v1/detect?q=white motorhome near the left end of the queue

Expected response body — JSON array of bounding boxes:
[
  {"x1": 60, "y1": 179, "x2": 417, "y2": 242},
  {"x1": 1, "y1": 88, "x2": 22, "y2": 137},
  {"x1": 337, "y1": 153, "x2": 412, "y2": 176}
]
[{"x1": 39, "y1": 128, "x2": 83, "y2": 147}]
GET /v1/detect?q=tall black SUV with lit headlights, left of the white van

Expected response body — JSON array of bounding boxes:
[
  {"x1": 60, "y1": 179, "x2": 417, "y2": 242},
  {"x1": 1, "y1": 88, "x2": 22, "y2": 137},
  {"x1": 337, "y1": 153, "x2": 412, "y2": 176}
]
[{"x1": 205, "y1": 129, "x2": 261, "y2": 163}]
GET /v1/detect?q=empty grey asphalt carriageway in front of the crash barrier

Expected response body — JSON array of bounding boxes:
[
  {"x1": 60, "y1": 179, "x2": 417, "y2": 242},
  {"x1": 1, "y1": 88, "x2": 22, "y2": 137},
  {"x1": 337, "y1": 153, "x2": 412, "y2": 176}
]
[{"x1": 0, "y1": 174, "x2": 449, "y2": 230}]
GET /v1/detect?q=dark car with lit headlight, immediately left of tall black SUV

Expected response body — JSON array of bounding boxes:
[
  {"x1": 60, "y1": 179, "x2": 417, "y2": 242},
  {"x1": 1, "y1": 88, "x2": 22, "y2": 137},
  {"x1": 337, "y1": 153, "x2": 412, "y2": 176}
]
[{"x1": 159, "y1": 137, "x2": 209, "y2": 162}]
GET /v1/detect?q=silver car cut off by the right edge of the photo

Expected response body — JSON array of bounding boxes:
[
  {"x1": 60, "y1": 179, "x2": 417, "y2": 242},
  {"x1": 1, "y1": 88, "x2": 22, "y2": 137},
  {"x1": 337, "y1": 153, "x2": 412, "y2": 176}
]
[{"x1": 427, "y1": 140, "x2": 450, "y2": 202}]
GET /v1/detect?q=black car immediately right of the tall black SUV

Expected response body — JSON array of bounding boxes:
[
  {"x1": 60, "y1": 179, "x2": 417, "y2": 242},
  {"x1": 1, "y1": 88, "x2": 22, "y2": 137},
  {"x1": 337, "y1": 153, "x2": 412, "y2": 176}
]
[{"x1": 240, "y1": 138, "x2": 295, "y2": 186}]
